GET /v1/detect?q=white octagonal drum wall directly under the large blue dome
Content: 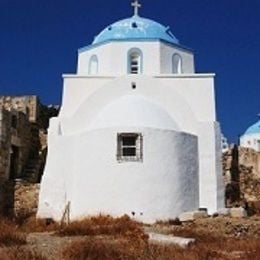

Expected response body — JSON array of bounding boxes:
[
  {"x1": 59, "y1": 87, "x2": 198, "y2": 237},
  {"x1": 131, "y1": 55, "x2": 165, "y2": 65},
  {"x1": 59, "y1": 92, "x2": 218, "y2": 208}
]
[{"x1": 77, "y1": 41, "x2": 194, "y2": 76}]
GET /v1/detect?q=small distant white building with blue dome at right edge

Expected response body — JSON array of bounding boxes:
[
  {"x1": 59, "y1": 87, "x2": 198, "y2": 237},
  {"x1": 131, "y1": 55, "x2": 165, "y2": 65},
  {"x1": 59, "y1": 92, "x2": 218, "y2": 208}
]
[{"x1": 240, "y1": 120, "x2": 260, "y2": 152}]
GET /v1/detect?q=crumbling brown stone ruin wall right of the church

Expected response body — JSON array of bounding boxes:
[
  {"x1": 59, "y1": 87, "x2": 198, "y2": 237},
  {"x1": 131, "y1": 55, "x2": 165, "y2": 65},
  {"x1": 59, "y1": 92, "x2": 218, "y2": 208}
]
[{"x1": 223, "y1": 146, "x2": 260, "y2": 214}]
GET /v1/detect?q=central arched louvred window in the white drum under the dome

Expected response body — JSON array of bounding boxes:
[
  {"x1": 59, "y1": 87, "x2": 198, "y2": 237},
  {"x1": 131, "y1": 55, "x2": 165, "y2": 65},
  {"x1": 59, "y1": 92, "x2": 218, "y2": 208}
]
[{"x1": 128, "y1": 49, "x2": 143, "y2": 74}]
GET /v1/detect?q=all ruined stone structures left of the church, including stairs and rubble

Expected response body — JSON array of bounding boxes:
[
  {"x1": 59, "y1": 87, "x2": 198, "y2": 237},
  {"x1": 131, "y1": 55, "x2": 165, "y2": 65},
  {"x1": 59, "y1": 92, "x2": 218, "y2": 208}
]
[{"x1": 0, "y1": 96, "x2": 58, "y2": 216}]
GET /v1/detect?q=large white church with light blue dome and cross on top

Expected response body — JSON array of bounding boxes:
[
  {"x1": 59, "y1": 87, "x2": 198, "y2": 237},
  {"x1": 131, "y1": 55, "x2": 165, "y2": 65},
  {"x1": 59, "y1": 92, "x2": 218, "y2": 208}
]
[{"x1": 38, "y1": 1, "x2": 224, "y2": 223}]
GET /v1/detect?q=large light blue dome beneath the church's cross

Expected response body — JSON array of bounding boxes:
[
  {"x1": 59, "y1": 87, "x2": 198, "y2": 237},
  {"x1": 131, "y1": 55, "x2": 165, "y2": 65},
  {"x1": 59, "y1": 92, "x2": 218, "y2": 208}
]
[{"x1": 92, "y1": 15, "x2": 179, "y2": 44}]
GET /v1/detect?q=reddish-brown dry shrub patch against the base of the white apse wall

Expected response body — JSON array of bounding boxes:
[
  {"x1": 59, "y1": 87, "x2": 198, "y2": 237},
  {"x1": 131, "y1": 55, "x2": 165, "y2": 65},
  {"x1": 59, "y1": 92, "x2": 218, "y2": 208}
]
[{"x1": 57, "y1": 215, "x2": 146, "y2": 239}]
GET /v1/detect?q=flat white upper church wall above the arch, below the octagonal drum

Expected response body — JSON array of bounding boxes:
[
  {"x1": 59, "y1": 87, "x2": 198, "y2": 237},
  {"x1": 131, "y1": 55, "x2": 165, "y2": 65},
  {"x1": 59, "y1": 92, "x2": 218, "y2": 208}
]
[{"x1": 60, "y1": 75, "x2": 215, "y2": 133}]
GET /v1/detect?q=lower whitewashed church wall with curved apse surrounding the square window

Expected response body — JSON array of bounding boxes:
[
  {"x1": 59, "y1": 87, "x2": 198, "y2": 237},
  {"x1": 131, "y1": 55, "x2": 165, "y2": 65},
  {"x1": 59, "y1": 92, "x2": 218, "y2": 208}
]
[{"x1": 38, "y1": 127, "x2": 199, "y2": 223}]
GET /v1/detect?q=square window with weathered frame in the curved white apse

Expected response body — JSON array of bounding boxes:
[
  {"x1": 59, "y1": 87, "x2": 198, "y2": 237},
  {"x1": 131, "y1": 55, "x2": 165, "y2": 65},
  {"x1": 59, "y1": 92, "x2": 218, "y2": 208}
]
[{"x1": 117, "y1": 133, "x2": 143, "y2": 162}]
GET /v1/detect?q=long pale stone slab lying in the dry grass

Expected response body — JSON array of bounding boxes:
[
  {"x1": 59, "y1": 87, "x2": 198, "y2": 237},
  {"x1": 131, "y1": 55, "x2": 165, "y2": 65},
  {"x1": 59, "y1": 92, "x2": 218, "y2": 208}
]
[{"x1": 148, "y1": 233, "x2": 195, "y2": 248}]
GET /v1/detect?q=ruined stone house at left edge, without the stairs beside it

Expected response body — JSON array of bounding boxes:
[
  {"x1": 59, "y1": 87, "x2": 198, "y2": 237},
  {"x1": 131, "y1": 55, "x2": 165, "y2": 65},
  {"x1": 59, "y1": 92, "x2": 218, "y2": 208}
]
[{"x1": 0, "y1": 96, "x2": 38, "y2": 214}]
